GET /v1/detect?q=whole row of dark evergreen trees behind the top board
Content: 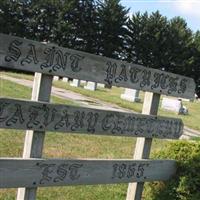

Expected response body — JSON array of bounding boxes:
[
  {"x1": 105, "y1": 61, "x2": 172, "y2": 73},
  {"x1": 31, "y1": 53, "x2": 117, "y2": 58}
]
[{"x1": 0, "y1": 0, "x2": 200, "y2": 95}]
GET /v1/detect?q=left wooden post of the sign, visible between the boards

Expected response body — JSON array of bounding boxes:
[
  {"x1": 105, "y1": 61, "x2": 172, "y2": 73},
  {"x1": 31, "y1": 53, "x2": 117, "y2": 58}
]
[{"x1": 17, "y1": 73, "x2": 53, "y2": 200}]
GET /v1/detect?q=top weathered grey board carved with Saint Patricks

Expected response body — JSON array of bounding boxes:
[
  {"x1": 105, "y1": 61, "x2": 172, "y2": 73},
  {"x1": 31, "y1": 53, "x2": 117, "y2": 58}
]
[{"x1": 0, "y1": 34, "x2": 195, "y2": 99}]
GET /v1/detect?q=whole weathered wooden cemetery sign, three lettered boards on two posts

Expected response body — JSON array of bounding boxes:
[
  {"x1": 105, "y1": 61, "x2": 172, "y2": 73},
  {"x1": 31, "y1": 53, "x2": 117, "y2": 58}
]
[{"x1": 0, "y1": 34, "x2": 195, "y2": 200}]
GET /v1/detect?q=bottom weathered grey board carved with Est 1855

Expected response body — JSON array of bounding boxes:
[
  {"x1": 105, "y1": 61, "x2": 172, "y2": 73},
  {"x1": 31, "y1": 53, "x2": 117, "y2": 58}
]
[{"x1": 0, "y1": 158, "x2": 176, "y2": 188}]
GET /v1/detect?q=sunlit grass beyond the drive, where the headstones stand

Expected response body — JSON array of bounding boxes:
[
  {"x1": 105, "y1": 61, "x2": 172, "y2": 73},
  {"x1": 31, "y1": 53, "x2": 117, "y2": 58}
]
[{"x1": 1, "y1": 72, "x2": 200, "y2": 131}]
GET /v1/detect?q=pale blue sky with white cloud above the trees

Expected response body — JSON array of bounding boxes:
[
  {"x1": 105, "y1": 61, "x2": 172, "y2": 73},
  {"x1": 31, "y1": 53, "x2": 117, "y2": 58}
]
[{"x1": 121, "y1": 0, "x2": 200, "y2": 32}]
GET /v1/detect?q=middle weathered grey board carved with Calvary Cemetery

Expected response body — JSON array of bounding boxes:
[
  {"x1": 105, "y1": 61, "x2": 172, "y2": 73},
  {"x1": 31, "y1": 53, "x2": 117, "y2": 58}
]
[{"x1": 0, "y1": 98, "x2": 183, "y2": 139}]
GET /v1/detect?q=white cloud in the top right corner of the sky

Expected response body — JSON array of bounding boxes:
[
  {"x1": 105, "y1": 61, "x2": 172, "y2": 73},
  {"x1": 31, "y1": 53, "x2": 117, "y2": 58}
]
[{"x1": 174, "y1": 0, "x2": 200, "y2": 18}]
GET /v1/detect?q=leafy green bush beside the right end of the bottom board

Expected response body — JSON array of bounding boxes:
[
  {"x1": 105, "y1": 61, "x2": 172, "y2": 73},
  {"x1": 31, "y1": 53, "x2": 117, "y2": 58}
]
[{"x1": 145, "y1": 141, "x2": 200, "y2": 200}]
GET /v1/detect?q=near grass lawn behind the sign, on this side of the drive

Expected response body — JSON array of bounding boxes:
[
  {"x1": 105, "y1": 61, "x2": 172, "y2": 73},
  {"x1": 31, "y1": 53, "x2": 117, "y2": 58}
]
[{"x1": 0, "y1": 76, "x2": 168, "y2": 200}]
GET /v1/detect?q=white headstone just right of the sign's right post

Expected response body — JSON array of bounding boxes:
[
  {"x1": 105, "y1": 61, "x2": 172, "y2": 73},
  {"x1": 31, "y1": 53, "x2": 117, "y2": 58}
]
[{"x1": 161, "y1": 97, "x2": 183, "y2": 113}]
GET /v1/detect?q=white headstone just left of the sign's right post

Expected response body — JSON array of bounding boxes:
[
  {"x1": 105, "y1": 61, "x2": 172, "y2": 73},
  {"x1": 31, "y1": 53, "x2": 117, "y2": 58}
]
[{"x1": 121, "y1": 88, "x2": 141, "y2": 102}]
